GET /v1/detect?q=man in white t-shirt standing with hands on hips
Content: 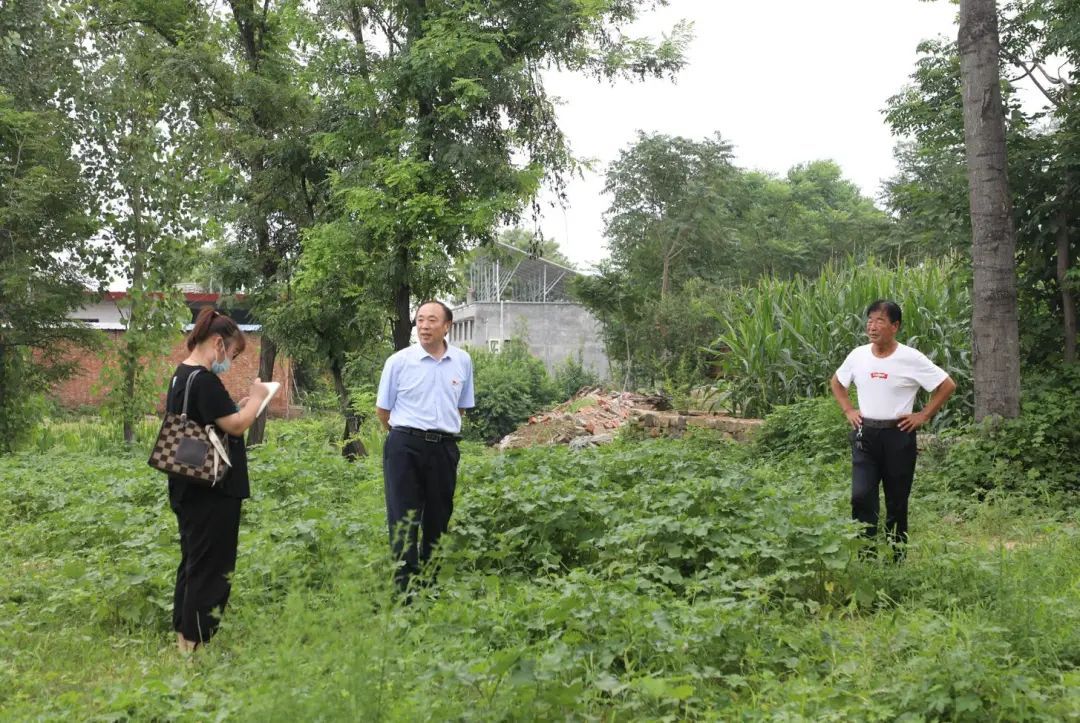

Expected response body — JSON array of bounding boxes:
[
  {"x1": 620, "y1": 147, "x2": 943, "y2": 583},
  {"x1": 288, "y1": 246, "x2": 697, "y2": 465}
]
[{"x1": 829, "y1": 299, "x2": 956, "y2": 560}]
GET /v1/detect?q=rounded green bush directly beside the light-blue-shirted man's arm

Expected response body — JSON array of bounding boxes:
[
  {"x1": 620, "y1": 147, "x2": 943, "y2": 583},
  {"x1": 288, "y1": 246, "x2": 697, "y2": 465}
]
[{"x1": 463, "y1": 339, "x2": 556, "y2": 443}]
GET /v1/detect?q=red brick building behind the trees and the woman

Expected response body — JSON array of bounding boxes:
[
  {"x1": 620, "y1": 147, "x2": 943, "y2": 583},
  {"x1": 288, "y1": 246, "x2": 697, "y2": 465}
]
[{"x1": 52, "y1": 292, "x2": 296, "y2": 416}]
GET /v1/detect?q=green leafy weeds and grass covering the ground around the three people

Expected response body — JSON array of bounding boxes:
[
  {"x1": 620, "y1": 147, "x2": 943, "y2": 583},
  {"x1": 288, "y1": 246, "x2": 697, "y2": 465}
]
[{"x1": 0, "y1": 419, "x2": 1080, "y2": 721}]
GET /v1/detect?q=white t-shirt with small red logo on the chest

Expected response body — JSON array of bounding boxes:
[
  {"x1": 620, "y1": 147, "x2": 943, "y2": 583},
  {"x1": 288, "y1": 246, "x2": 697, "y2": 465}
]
[{"x1": 836, "y1": 344, "x2": 948, "y2": 419}]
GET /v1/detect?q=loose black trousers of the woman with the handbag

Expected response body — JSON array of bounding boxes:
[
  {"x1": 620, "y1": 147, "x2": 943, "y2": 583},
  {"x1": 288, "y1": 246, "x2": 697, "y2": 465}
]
[{"x1": 168, "y1": 482, "x2": 241, "y2": 643}]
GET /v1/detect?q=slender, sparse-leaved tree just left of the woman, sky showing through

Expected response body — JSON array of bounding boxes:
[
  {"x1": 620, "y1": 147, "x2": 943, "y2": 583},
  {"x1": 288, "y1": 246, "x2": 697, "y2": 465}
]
[{"x1": 76, "y1": 7, "x2": 205, "y2": 443}]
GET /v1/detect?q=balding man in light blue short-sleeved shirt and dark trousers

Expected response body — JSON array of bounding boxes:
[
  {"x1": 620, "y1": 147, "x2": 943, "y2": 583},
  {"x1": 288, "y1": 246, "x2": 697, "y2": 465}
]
[{"x1": 375, "y1": 302, "x2": 474, "y2": 591}]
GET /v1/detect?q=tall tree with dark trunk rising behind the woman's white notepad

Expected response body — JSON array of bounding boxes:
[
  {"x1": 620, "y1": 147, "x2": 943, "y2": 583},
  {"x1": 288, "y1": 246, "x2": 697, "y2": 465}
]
[{"x1": 210, "y1": 0, "x2": 319, "y2": 444}]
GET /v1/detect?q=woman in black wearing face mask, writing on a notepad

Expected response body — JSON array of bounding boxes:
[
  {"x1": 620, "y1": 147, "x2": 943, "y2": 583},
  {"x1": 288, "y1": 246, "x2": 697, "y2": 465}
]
[{"x1": 168, "y1": 307, "x2": 267, "y2": 652}]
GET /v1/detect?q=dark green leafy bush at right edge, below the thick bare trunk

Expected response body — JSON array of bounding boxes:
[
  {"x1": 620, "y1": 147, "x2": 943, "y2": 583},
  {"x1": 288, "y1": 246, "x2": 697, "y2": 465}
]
[{"x1": 935, "y1": 365, "x2": 1080, "y2": 498}]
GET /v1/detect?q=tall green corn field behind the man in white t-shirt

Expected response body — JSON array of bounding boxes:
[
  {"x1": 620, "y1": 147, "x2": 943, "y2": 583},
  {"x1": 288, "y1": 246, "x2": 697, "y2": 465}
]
[{"x1": 712, "y1": 259, "x2": 974, "y2": 427}]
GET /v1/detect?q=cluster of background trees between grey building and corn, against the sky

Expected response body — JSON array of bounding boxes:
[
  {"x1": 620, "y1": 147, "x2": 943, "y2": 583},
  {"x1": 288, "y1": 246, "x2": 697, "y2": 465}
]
[{"x1": 575, "y1": 142, "x2": 892, "y2": 388}]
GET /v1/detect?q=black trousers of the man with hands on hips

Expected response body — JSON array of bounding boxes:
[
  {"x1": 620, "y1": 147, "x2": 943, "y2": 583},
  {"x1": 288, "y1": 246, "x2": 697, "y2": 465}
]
[{"x1": 851, "y1": 427, "x2": 918, "y2": 544}]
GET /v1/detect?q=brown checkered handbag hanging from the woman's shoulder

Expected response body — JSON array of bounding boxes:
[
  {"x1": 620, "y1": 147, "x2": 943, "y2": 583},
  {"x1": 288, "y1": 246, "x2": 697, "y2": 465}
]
[{"x1": 147, "y1": 370, "x2": 231, "y2": 487}]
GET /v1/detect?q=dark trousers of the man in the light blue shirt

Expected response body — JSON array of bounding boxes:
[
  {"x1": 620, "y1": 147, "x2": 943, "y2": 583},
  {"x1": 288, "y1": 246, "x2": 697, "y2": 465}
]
[{"x1": 382, "y1": 430, "x2": 460, "y2": 590}]
